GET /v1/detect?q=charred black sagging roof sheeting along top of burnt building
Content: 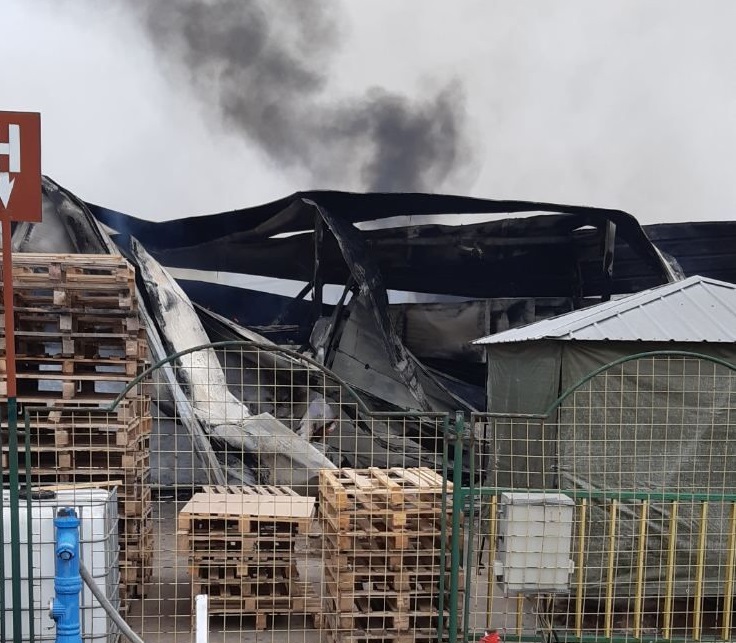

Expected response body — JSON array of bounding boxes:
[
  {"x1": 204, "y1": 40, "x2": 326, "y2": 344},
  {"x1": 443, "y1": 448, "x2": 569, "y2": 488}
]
[{"x1": 89, "y1": 191, "x2": 669, "y2": 298}]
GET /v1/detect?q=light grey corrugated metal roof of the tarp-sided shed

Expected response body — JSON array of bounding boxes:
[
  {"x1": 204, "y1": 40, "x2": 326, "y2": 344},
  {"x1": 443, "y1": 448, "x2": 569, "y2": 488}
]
[{"x1": 473, "y1": 276, "x2": 736, "y2": 344}]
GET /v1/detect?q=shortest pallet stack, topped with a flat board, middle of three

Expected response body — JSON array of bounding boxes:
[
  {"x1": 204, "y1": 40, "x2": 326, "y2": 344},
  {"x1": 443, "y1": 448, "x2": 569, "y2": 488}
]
[{"x1": 178, "y1": 486, "x2": 321, "y2": 630}]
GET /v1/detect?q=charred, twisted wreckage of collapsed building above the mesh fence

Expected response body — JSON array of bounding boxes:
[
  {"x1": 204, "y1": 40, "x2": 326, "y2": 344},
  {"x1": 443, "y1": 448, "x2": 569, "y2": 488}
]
[{"x1": 13, "y1": 178, "x2": 736, "y2": 488}]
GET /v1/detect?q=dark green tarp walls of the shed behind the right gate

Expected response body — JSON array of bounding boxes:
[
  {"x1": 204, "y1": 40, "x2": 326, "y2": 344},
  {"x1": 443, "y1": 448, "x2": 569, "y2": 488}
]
[{"x1": 489, "y1": 340, "x2": 736, "y2": 596}]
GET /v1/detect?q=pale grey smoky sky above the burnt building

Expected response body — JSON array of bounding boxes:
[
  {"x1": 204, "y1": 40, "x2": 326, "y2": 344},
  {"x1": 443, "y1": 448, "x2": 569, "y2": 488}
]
[{"x1": 0, "y1": 0, "x2": 736, "y2": 224}]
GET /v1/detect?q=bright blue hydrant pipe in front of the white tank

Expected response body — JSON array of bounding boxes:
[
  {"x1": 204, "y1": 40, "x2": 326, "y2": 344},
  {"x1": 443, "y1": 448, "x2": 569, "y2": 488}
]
[{"x1": 50, "y1": 507, "x2": 82, "y2": 643}]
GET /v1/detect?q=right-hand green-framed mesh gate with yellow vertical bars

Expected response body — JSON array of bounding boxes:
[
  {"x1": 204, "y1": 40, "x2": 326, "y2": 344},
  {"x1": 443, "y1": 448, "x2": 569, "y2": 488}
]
[{"x1": 456, "y1": 351, "x2": 736, "y2": 641}]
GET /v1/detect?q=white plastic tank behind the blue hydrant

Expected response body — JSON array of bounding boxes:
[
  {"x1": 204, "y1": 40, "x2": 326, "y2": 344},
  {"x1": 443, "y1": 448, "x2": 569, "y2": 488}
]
[{"x1": 3, "y1": 489, "x2": 120, "y2": 643}]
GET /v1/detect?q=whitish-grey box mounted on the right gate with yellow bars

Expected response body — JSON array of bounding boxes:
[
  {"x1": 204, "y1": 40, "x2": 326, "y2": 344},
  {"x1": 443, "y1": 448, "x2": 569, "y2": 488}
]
[{"x1": 494, "y1": 492, "x2": 575, "y2": 594}]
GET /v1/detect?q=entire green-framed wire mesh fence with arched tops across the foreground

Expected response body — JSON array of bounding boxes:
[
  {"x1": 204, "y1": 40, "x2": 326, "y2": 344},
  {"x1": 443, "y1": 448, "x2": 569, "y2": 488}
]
[{"x1": 0, "y1": 350, "x2": 736, "y2": 643}]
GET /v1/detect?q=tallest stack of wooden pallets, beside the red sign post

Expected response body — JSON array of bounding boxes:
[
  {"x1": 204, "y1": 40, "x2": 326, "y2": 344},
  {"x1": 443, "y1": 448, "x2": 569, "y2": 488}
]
[{"x1": 0, "y1": 253, "x2": 153, "y2": 604}]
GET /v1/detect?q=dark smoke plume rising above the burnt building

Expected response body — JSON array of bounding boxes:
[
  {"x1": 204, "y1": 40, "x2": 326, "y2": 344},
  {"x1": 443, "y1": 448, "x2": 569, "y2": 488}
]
[{"x1": 126, "y1": 0, "x2": 472, "y2": 191}]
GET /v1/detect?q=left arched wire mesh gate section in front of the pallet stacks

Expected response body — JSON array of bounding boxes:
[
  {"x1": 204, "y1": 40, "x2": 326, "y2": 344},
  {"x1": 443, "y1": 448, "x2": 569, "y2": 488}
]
[{"x1": 0, "y1": 342, "x2": 454, "y2": 643}]
